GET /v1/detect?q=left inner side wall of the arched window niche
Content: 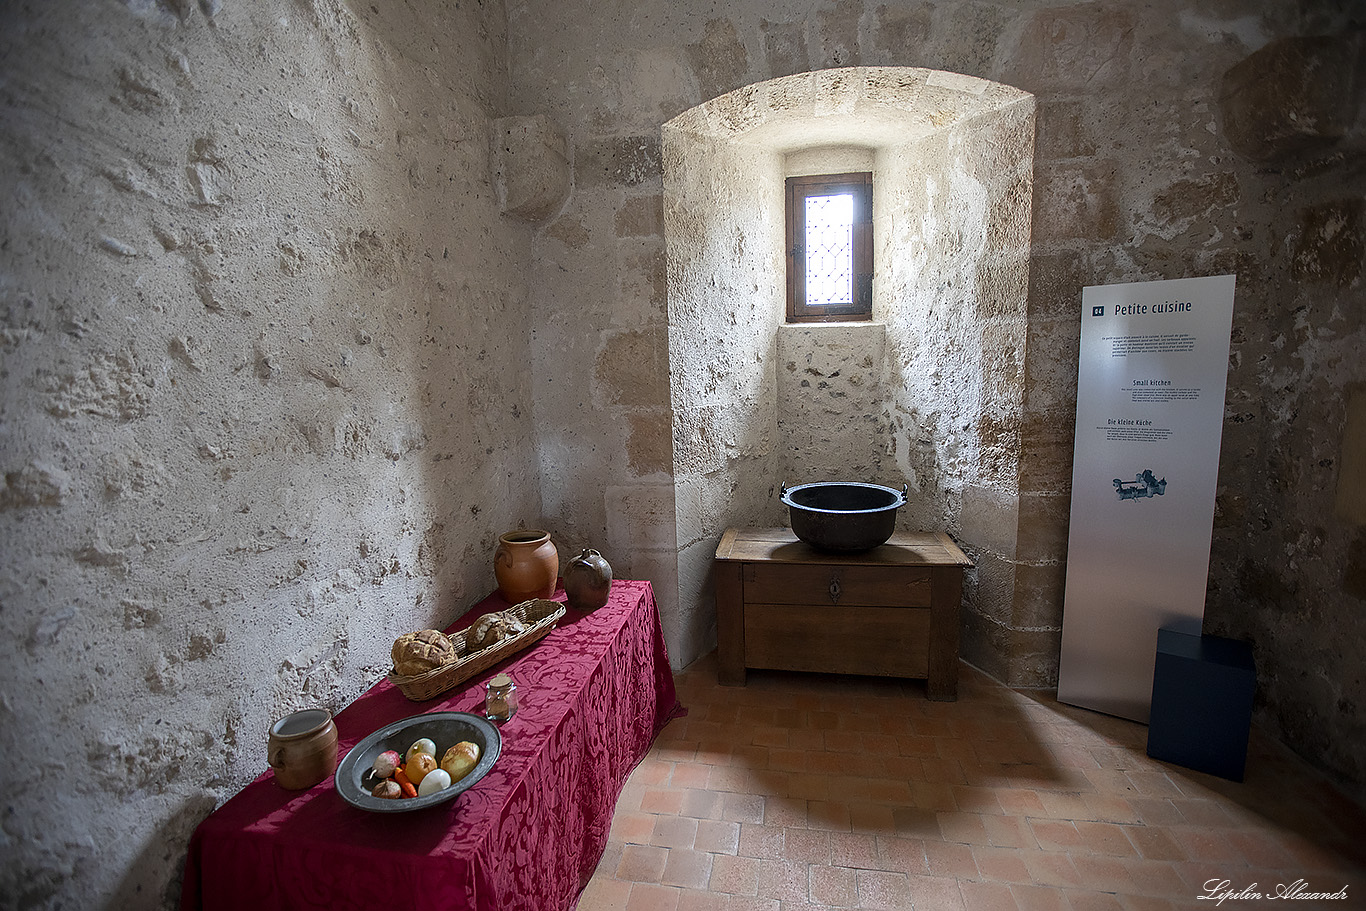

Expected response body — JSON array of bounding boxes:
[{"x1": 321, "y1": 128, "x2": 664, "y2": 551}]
[{"x1": 657, "y1": 128, "x2": 783, "y2": 664}]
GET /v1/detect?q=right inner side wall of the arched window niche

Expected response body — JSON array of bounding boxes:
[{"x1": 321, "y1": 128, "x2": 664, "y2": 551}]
[{"x1": 881, "y1": 99, "x2": 1032, "y2": 686}]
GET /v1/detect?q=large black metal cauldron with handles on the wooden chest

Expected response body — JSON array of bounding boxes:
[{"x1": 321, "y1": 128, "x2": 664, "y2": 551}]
[{"x1": 779, "y1": 481, "x2": 906, "y2": 552}]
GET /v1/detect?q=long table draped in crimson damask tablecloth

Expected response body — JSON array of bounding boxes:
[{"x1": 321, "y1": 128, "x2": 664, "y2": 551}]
[{"x1": 180, "y1": 579, "x2": 683, "y2": 911}]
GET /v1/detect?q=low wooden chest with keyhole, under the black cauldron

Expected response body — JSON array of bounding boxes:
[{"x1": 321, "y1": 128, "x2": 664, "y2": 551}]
[{"x1": 716, "y1": 529, "x2": 971, "y2": 699}]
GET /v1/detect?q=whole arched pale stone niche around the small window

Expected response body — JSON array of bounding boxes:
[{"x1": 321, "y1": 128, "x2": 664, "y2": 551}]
[{"x1": 663, "y1": 67, "x2": 1034, "y2": 677}]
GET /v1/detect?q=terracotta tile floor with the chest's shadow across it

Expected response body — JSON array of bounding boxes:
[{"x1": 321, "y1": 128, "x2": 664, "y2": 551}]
[{"x1": 578, "y1": 654, "x2": 1366, "y2": 911}]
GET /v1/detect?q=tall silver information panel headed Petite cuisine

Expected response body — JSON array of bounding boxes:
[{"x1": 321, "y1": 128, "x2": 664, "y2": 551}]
[{"x1": 1057, "y1": 275, "x2": 1235, "y2": 723}]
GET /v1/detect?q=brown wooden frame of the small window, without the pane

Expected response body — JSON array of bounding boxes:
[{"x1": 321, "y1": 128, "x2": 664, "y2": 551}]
[{"x1": 785, "y1": 171, "x2": 873, "y2": 322}]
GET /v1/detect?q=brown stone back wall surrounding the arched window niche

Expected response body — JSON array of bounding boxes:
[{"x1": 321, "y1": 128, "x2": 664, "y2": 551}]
[{"x1": 510, "y1": 0, "x2": 1366, "y2": 783}]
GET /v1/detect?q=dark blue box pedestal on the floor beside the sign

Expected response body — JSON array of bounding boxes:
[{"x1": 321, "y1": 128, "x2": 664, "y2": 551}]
[{"x1": 1147, "y1": 628, "x2": 1257, "y2": 781}]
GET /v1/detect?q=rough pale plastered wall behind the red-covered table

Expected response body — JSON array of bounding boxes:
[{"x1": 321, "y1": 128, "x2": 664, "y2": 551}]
[{"x1": 0, "y1": 0, "x2": 541, "y2": 908}]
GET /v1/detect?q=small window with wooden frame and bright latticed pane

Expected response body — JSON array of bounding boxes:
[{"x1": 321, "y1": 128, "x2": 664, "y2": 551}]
[{"x1": 787, "y1": 171, "x2": 873, "y2": 322}]
